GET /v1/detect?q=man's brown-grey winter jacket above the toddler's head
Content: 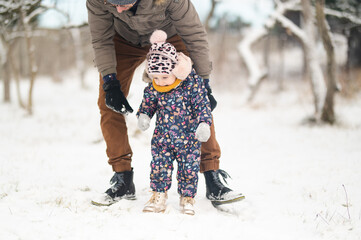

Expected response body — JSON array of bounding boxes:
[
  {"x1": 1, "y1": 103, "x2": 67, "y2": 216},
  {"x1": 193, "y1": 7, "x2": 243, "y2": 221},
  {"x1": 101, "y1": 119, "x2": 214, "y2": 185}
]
[{"x1": 86, "y1": 0, "x2": 212, "y2": 78}]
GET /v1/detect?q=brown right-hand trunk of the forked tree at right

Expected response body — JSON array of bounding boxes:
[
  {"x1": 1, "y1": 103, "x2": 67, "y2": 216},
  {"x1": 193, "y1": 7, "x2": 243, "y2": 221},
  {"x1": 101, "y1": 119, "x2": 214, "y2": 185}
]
[{"x1": 316, "y1": 0, "x2": 337, "y2": 124}]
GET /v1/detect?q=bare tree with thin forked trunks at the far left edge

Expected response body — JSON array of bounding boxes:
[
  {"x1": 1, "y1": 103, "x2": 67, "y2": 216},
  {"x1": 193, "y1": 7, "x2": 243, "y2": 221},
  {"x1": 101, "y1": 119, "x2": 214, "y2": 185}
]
[{"x1": 0, "y1": 0, "x2": 69, "y2": 115}]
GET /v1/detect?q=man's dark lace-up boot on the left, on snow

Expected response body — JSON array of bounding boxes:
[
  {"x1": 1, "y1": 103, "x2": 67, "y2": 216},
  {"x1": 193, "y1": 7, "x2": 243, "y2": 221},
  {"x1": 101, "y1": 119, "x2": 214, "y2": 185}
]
[{"x1": 92, "y1": 169, "x2": 135, "y2": 206}]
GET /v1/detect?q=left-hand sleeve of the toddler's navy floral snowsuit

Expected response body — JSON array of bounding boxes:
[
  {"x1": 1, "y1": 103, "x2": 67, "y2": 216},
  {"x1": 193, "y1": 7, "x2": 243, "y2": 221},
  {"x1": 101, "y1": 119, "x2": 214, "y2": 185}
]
[{"x1": 137, "y1": 83, "x2": 158, "y2": 118}]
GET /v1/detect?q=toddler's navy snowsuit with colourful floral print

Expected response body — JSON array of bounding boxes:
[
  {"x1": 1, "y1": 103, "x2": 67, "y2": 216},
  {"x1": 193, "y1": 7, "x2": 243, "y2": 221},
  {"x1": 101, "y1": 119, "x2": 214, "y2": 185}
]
[{"x1": 137, "y1": 70, "x2": 212, "y2": 197}]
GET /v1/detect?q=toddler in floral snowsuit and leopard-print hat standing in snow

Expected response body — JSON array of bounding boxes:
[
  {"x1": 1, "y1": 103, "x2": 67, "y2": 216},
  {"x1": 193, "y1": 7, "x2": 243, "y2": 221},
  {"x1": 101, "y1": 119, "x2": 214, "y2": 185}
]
[{"x1": 137, "y1": 30, "x2": 212, "y2": 215}]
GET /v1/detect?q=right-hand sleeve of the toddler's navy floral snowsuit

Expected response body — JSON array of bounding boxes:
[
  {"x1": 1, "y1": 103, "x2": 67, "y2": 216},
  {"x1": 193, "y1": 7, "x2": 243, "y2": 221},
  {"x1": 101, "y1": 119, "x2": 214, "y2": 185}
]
[{"x1": 190, "y1": 74, "x2": 212, "y2": 126}]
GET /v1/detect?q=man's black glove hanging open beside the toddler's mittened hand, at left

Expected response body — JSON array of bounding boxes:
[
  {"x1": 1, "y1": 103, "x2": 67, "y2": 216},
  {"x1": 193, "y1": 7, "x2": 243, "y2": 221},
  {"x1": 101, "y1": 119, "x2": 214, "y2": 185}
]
[{"x1": 103, "y1": 73, "x2": 133, "y2": 114}]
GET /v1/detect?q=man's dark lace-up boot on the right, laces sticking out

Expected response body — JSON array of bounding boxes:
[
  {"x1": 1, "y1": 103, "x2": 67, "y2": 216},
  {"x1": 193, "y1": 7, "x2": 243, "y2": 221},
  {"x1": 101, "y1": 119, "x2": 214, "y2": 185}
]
[{"x1": 204, "y1": 169, "x2": 244, "y2": 205}]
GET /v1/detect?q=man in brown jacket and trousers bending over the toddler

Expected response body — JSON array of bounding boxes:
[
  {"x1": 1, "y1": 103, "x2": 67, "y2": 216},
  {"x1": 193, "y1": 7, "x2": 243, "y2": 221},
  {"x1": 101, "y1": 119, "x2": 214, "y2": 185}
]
[{"x1": 86, "y1": 0, "x2": 244, "y2": 205}]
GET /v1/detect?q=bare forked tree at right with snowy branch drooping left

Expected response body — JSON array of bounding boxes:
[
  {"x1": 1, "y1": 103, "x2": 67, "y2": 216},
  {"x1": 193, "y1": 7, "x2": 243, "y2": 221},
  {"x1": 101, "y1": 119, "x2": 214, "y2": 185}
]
[{"x1": 239, "y1": 0, "x2": 344, "y2": 123}]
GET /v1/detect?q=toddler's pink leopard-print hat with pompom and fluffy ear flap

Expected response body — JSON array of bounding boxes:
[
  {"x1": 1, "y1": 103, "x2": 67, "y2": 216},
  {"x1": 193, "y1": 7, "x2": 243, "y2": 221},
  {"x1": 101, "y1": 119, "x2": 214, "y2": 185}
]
[{"x1": 147, "y1": 30, "x2": 192, "y2": 80}]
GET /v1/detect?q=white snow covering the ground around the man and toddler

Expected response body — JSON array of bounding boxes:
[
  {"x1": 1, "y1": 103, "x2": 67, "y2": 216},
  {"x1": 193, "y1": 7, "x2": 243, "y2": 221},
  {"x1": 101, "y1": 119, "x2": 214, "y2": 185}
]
[{"x1": 0, "y1": 70, "x2": 361, "y2": 240}]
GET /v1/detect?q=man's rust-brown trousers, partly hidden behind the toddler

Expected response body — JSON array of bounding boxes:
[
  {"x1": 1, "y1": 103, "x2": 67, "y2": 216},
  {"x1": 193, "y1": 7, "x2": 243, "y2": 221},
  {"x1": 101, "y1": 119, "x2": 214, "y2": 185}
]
[{"x1": 98, "y1": 35, "x2": 221, "y2": 172}]
